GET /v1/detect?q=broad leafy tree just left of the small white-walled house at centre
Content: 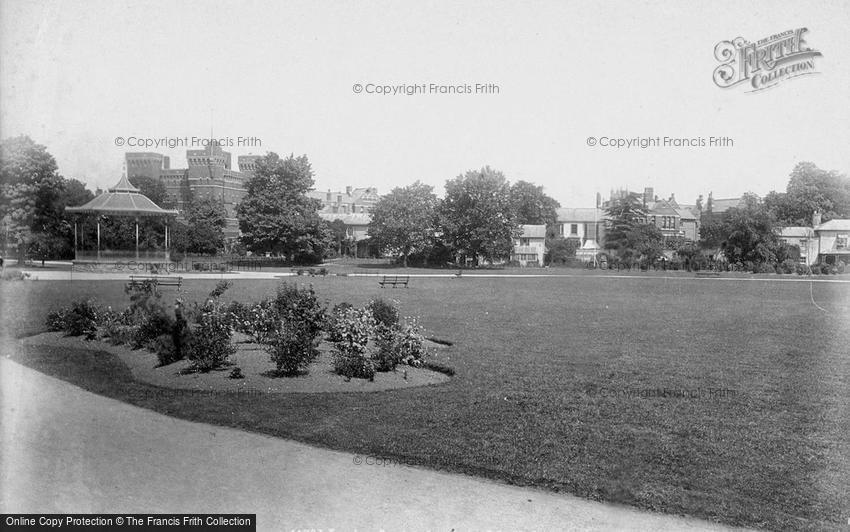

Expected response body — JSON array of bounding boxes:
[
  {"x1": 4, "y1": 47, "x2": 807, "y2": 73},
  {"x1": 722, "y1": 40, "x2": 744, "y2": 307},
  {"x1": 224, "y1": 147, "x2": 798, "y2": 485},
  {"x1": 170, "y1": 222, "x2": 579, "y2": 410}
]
[{"x1": 438, "y1": 166, "x2": 520, "y2": 264}]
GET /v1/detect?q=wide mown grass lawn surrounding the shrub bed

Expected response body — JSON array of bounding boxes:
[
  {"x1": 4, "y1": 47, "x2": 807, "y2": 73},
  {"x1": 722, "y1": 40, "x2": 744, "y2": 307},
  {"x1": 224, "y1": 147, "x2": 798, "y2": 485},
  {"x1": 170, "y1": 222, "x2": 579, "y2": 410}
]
[{"x1": 0, "y1": 272, "x2": 850, "y2": 530}]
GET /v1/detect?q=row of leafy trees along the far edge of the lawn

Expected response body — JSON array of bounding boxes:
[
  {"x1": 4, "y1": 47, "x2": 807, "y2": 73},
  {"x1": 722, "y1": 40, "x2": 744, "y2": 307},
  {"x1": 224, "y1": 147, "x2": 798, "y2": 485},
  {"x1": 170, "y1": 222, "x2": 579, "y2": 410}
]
[{"x1": 0, "y1": 136, "x2": 850, "y2": 266}]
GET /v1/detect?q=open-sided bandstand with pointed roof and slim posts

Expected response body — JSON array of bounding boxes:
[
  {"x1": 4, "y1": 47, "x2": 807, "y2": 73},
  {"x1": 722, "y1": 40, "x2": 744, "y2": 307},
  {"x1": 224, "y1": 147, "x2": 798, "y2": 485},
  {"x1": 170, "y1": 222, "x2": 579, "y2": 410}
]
[{"x1": 65, "y1": 173, "x2": 177, "y2": 270}]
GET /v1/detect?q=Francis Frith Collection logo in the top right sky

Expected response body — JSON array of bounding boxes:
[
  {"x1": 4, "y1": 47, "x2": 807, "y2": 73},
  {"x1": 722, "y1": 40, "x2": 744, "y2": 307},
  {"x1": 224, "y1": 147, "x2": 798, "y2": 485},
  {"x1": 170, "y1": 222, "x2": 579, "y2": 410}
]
[{"x1": 714, "y1": 28, "x2": 821, "y2": 92}]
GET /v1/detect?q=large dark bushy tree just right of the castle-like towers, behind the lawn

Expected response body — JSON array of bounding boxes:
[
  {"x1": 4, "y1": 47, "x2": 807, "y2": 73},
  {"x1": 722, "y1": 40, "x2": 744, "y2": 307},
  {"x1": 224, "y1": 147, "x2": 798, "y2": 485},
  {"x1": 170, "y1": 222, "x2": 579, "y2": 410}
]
[{"x1": 236, "y1": 152, "x2": 330, "y2": 261}]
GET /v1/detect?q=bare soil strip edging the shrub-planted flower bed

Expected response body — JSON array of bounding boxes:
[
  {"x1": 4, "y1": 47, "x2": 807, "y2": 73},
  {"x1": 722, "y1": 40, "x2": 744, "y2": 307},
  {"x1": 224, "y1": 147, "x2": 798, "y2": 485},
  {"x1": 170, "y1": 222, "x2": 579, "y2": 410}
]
[{"x1": 21, "y1": 332, "x2": 450, "y2": 393}]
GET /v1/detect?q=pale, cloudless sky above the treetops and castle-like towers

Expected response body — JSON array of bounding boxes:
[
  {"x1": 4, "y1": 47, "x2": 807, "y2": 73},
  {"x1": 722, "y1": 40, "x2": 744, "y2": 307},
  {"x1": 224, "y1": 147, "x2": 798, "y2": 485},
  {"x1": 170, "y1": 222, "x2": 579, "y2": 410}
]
[{"x1": 0, "y1": 0, "x2": 850, "y2": 207}]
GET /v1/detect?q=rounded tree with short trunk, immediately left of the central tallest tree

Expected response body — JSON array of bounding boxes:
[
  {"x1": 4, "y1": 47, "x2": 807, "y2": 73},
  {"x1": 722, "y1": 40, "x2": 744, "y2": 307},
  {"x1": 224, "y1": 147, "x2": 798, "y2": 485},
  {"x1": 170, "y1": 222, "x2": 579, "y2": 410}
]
[{"x1": 369, "y1": 181, "x2": 437, "y2": 268}]
